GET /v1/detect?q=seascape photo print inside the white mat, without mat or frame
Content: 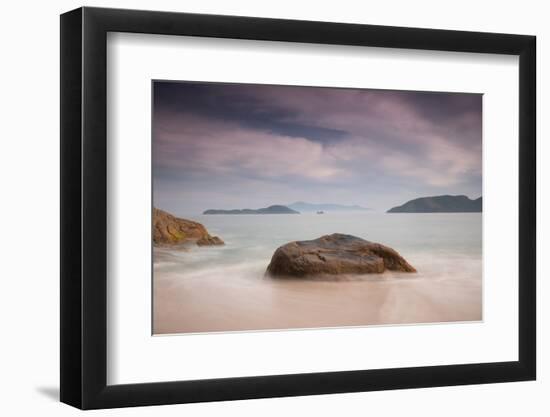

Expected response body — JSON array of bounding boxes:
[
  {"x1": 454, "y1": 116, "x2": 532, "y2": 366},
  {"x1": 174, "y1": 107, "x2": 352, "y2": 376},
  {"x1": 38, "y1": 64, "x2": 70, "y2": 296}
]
[{"x1": 152, "y1": 80, "x2": 483, "y2": 335}]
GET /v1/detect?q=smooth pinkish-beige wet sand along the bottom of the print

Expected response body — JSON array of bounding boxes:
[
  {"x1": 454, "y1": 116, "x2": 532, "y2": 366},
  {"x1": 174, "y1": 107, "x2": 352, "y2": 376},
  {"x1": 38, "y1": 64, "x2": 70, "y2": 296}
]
[{"x1": 153, "y1": 266, "x2": 482, "y2": 334}]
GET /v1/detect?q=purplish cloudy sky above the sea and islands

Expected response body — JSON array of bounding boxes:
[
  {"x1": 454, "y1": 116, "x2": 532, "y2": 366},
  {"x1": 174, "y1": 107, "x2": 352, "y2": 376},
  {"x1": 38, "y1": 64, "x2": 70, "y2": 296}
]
[{"x1": 153, "y1": 81, "x2": 482, "y2": 214}]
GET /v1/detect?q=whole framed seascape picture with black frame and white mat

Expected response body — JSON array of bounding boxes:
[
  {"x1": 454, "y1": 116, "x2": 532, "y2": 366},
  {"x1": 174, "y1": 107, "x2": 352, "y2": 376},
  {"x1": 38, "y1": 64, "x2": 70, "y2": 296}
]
[{"x1": 60, "y1": 7, "x2": 536, "y2": 409}]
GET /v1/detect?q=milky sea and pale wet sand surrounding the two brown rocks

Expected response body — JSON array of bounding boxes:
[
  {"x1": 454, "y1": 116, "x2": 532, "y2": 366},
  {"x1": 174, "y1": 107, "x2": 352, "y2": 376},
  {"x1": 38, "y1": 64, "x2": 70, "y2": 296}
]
[{"x1": 153, "y1": 212, "x2": 482, "y2": 334}]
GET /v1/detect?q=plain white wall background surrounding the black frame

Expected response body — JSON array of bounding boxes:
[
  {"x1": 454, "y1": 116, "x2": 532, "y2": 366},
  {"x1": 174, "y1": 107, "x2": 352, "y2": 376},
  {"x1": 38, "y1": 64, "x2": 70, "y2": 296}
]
[{"x1": 0, "y1": 0, "x2": 550, "y2": 417}]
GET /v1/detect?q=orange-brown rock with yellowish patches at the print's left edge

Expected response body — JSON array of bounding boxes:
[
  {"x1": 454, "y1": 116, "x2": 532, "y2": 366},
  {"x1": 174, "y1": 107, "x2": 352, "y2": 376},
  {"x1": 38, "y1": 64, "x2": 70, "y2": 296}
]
[{"x1": 153, "y1": 208, "x2": 224, "y2": 246}]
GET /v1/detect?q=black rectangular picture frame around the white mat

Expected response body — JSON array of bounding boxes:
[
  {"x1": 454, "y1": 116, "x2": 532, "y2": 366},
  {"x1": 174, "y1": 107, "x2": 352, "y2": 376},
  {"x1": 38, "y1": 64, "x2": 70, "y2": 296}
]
[{"x1": 60, "y1": 7, "x2": 536, "y2": 409}]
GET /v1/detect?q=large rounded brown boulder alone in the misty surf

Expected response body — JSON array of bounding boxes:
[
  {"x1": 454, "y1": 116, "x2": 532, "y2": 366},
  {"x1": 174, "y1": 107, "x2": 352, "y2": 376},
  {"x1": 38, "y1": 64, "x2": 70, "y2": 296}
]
[{"x1": 266, "y1": 233, "x2": 416, "y2": 277}]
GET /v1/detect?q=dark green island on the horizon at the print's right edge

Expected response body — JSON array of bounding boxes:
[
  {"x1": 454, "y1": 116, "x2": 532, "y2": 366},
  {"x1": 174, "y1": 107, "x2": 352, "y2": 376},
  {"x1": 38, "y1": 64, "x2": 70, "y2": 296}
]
[{"x1": 388, "y1": 195, "x2": 482, "y2": 213}]
